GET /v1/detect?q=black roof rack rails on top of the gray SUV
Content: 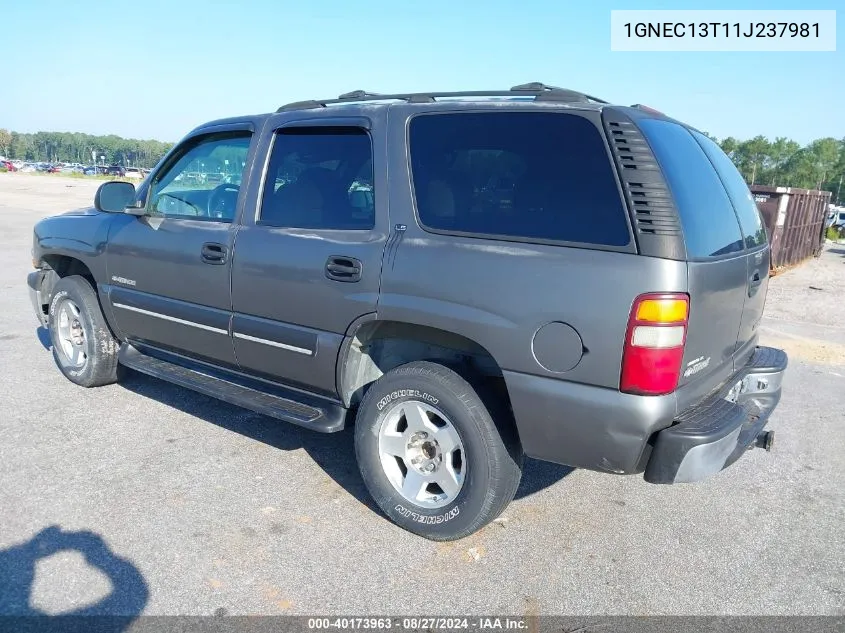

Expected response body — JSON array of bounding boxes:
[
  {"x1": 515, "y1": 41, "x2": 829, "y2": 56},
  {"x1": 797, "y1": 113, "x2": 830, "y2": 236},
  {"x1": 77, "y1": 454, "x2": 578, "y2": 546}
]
[{"x1": 276, "y1": 81, "x2": 607, "y2": 112}]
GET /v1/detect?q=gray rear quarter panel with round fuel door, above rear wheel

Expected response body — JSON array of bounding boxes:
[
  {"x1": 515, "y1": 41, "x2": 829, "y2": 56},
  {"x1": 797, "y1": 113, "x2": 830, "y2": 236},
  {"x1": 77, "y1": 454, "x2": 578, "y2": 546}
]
[{"x1": 378, "y1": 236, "x2": 687, "y2": 389}]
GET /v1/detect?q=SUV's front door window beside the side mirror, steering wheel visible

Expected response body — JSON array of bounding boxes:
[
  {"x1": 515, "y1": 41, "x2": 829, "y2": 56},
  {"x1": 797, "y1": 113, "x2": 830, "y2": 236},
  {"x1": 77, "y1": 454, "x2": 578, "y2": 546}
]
[{"x1": 147, "y1": 132, "x2": 252, "y2": 222}]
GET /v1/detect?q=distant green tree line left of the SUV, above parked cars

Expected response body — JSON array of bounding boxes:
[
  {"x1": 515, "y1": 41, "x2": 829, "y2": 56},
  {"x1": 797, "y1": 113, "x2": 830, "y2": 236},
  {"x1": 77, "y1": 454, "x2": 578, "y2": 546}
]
[{"x1": 0, "y1": 129, "x2": 173, "y2": 168}]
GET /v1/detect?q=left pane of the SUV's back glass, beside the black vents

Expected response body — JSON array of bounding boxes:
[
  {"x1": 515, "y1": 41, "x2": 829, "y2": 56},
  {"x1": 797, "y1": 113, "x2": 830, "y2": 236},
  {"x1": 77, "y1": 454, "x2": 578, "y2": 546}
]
[{"x1": 638, "y1": 119, "x2": 743, "y2": 258}]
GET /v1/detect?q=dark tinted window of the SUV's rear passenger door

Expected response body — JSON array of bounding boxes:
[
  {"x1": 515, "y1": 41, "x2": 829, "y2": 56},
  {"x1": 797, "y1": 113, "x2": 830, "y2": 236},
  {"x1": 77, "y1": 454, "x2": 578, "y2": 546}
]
[{"x1": 258, "y1": 127, "x2": 375, "y2": 230}]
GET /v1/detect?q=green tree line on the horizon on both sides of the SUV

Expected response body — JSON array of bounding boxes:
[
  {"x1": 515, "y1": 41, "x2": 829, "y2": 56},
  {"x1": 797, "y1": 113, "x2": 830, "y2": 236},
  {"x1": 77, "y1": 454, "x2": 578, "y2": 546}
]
[{"x1": 0, "y1": 124, "x2": 845, "y2": 202}]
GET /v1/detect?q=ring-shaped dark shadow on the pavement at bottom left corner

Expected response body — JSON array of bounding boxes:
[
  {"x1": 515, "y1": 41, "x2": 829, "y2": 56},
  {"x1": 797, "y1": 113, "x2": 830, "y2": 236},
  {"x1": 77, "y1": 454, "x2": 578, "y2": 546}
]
[{"x1": 0, "y1": 526, "x2": 149, "y2": 633}]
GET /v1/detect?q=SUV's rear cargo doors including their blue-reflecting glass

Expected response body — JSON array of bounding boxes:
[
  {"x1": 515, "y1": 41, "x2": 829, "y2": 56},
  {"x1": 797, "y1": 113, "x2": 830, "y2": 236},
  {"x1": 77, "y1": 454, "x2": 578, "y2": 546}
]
[{"x1": 637, "y1": 119, "x2": 769, "y2": 406}]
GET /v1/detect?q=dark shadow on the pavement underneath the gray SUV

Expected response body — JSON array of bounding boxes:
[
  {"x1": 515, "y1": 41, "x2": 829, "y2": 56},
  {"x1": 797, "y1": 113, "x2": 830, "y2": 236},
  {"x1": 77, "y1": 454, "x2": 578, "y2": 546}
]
[{"x1": 120, "y1": 371, "x2": 573, "y2": 514}]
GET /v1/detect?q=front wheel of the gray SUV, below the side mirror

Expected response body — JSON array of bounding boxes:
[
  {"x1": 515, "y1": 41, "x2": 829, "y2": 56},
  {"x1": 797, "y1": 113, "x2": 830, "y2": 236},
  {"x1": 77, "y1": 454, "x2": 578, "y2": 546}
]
[{"x1": 47, "y1": 276, "x2": 120, "y2": 387}]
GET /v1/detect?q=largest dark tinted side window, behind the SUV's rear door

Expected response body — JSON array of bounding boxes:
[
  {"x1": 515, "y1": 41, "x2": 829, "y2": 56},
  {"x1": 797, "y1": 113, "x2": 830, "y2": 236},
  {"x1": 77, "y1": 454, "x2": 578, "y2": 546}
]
[{"x1": 409, "y1": 112, "x2": 630, "y2": 246}]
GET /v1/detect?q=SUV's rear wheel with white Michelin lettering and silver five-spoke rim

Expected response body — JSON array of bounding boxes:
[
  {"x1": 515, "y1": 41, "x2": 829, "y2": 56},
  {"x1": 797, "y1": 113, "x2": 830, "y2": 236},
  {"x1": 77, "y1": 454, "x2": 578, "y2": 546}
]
[{"x1": 355, "y1": 361, "x2": 522, "y2": 541}]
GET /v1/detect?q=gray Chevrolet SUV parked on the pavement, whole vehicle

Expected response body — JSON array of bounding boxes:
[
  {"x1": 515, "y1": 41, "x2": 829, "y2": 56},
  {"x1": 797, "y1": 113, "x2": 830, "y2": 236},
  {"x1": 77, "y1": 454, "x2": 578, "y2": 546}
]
[{"x1": 28, "y1": 83, "x2": 787, "y2": 540}]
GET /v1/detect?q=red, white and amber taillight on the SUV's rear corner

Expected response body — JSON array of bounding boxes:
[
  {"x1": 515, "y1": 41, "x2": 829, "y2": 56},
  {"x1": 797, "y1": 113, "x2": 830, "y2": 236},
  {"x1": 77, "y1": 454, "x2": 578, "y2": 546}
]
[{"x1": 619, "y1": 293, "x2": 689, "y2": 396}]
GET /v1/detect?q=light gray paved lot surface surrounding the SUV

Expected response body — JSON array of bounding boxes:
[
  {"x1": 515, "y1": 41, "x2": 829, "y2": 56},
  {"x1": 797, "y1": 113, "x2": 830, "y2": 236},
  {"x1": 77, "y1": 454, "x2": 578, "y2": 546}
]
[{"x1": 0, "y1": 174, "x2": 845, "y2": 615}]
